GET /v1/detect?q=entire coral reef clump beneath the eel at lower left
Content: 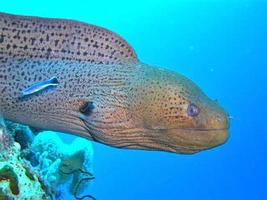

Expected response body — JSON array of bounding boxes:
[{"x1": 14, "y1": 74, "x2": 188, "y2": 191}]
[{"x1": 0, "y1": 122, "x2": 95, "y2": 200}]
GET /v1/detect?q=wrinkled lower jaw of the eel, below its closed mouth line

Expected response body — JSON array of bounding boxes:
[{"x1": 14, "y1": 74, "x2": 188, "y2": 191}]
[{"x1": 98, "y1": 129, "x2": 228, "y2": 154}]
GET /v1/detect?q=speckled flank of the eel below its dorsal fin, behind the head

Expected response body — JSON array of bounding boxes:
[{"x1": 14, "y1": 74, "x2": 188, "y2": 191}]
[{"x1": 0, "y1": 56, "x2": 138, "y2": 137}]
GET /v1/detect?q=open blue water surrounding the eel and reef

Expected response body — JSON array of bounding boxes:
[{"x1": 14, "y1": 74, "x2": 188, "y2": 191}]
[{"x1": 0, "y1": 0, "x2": 267, "y2": 200}]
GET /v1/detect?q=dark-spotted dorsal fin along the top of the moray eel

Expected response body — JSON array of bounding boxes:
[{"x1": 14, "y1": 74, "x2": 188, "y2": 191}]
[{"x1": 0, "y1": 13, "x2": 137, "y2": 64}]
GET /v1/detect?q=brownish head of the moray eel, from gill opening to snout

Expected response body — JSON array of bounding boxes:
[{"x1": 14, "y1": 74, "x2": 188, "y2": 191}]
[{"x1": 82, "y1": 66, "x2": 229, "y2": 154}]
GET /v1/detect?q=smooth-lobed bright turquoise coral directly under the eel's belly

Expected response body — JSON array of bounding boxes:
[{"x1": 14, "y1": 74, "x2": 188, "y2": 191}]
[{"x1": 31, "y1": 131, "x2": 93, "y2": 199}]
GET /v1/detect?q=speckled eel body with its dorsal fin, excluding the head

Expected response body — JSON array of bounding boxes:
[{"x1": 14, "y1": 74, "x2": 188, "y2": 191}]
[{"x1": 0, "y1": 14, "x2": 137, "y2": 137}]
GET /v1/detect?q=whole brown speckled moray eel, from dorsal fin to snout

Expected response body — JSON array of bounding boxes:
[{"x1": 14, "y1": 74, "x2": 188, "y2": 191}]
[{"x1": 0, "y1": 13, "x2": 229, "y2": 154}]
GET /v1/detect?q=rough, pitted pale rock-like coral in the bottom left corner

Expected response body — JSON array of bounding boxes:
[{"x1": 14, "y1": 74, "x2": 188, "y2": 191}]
[{"x1": 0, "y1": 125, "x2": 50, "y2": 200}]
